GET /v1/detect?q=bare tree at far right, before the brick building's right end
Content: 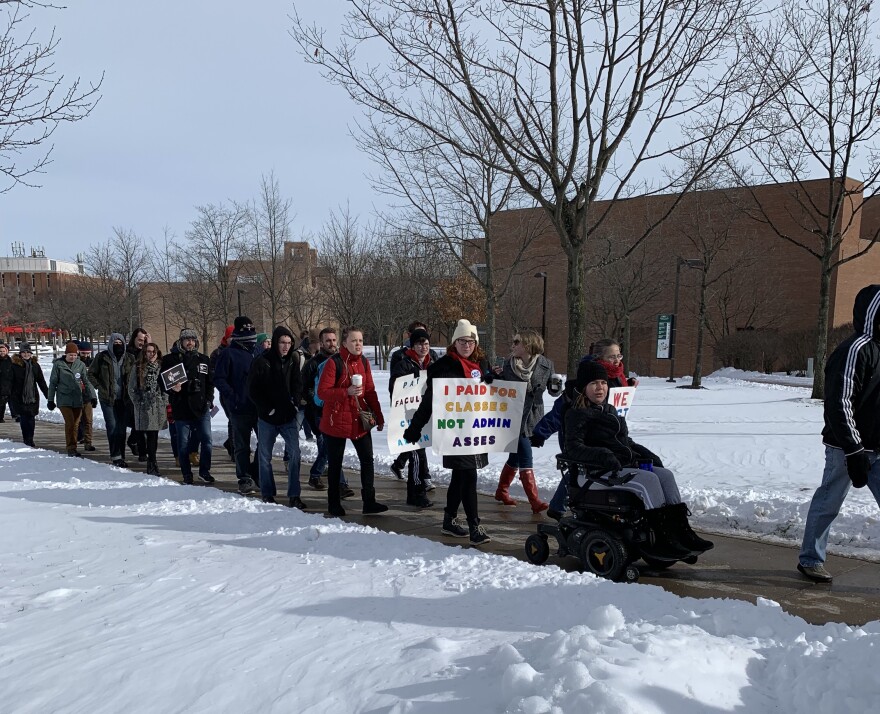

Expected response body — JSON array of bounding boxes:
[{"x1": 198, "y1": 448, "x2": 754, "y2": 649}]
[{"x1": 740, "y1": 0, "x2": 880, "y2": 399}]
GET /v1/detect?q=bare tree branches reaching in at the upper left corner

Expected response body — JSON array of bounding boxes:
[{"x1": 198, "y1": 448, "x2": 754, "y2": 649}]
[{"x1": 0, "y1": 0, "x2": 101, "y2": 192}]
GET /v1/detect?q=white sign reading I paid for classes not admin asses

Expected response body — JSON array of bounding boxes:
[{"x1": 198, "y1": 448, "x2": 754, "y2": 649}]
[{"x1": 431, "y1": 378, "x2": 526, "y2": 456}]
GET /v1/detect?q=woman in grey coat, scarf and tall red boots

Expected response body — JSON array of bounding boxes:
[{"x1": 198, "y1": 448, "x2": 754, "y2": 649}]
[{"x1": 495, "y1": 330, "x2": 562, "y2": 513}]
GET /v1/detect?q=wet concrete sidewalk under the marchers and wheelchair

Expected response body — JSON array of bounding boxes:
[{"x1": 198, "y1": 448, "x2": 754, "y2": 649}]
[{"x1": 0, "y1": 417, "x2": 880, "y2": 625}]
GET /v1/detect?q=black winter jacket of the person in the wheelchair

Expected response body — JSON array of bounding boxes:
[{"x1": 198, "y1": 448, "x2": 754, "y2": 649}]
[{"x1": 564, "y1": 403, "x2": 663, "y2": 471}]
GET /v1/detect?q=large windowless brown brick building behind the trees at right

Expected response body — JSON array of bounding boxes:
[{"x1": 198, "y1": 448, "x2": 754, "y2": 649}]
[{"x1": 493, "y1": 180, "x2": 880, "y2": 376}]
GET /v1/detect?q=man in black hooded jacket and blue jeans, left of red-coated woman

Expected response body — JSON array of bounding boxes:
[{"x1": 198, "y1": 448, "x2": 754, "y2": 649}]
[{"x1": 248, "y1": 325, "x2": 306, "y2": 510}]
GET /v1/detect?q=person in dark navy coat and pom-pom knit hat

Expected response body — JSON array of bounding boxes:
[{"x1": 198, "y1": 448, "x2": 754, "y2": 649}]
[{"x1": 214, "y1": 315, "x2": 257, "y2": 495}]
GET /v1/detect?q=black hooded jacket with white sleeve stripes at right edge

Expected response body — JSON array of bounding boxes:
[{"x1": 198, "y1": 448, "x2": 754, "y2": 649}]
[{"x1": 822, "y1": 285, "x2": 880, "y2": 456}]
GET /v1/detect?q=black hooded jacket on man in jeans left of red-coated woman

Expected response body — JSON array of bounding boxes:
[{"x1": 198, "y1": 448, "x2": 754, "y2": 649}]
[{"x1": 247, "y1": 327, "x2": 302, "y2": 426}]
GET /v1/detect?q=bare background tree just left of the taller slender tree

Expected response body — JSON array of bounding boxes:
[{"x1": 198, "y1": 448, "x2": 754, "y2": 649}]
[{"x1": 180, "y1": 204, "x2": 247, "y2": 325}]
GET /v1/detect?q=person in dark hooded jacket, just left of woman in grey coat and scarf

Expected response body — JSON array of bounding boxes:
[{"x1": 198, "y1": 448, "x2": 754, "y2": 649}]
[{"x1": 88, "y1": 332, "x2": 134, "y2": 468}]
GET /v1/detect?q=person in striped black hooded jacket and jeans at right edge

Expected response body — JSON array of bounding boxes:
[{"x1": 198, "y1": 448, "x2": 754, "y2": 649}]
[{"x1": 798, "y1": 285, "x2": 880, "y2": 583}]
